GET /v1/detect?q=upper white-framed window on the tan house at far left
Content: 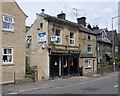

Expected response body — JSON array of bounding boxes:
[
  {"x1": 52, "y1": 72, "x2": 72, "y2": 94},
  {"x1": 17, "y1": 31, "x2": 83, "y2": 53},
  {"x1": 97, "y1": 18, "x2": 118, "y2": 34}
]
[{"x1": 3, "y1": 15, "x2": 14, "y2": 31}]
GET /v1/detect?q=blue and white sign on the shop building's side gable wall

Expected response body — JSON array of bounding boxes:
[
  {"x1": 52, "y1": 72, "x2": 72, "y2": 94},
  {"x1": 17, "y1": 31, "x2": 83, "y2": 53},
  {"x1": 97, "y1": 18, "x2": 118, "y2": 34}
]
[{"x1": 37, "y1": 32, "x2": 47, "y2": 44}]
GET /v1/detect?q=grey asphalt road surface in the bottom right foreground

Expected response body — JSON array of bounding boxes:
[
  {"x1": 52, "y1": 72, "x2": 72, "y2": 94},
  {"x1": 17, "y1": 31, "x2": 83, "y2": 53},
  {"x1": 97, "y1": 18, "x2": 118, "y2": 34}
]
[{"x1": 19, "y1": 74, "x2": 118, "y2": 94}]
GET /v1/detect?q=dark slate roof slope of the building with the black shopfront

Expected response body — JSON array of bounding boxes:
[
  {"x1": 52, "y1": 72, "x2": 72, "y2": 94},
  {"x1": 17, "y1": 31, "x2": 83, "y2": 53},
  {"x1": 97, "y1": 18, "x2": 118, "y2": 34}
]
[{"x1": 37, "y1": 13, "x2": 96, "y2": 35}]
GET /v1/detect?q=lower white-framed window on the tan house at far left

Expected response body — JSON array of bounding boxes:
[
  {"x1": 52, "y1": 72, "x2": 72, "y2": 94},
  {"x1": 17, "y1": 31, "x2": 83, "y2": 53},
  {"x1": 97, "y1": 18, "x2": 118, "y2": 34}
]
[{"x1": 2, "y1": 48, "x2": 13, "y2": 64}]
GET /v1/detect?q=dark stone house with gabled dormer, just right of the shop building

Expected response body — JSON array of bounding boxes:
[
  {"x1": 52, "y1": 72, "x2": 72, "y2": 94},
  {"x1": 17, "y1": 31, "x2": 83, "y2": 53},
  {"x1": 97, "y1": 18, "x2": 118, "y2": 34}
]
[{"x1": 93, "y1": 26, "x2": 112, "y2": 63}]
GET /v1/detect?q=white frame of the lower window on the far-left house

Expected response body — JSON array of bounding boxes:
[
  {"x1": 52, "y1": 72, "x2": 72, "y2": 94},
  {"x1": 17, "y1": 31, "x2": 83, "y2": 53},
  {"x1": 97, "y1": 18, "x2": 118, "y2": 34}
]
[{"x1": 2, "y1": 47, "x2": 14, "y2": 65}]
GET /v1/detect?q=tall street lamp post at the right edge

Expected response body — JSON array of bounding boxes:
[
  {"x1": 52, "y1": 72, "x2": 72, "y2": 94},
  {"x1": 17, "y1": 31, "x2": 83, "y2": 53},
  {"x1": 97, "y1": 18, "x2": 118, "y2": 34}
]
[{"x1": 112, "y1": 16, "x2": 120, "y2": 72}]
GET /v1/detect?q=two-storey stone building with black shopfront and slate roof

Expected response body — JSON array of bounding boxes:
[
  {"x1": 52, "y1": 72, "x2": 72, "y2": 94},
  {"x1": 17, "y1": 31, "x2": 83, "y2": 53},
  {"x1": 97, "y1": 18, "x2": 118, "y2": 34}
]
[{"x1": 26, "y1": 9, "x2": 97, "y2": 80}]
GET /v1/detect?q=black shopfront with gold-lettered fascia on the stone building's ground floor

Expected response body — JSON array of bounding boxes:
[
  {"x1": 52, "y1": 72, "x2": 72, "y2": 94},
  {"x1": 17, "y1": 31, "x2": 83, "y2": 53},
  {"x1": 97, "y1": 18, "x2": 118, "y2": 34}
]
[{"x1": 49, "y1": 49, "x2": 80, "y2": 77}]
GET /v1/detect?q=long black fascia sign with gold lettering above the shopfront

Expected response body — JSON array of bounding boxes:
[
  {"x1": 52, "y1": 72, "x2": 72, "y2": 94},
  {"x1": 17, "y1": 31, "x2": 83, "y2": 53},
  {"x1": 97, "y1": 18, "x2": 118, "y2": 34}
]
[{"x1": 51, "y1": 49, "x2": 80, "y2": 54}]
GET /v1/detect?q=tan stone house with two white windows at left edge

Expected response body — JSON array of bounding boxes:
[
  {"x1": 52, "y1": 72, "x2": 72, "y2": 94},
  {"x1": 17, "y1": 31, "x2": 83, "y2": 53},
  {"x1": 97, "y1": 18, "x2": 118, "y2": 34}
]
[{"x1": 0, "y1": 0, "x2": 27, "y2": 84}]
